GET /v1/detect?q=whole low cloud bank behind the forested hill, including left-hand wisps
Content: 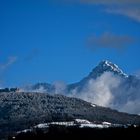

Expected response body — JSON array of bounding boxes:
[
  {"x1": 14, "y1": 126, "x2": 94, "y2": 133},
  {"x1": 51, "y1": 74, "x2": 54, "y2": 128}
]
[{"x1": 25, "y1": 72, "x2": 140, "y2": 114}]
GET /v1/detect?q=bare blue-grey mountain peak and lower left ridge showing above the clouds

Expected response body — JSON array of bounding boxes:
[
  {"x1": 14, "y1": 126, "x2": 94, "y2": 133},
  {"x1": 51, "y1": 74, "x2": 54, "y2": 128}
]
[{"x1": 23, "y1": 60, "x2": 128, "y2": 94}]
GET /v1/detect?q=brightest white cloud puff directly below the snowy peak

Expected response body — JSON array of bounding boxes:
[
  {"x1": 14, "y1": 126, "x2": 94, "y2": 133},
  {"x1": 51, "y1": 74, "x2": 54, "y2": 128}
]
[{"x1": 72, "y1": 72, "x2": 120, "y2": 107}]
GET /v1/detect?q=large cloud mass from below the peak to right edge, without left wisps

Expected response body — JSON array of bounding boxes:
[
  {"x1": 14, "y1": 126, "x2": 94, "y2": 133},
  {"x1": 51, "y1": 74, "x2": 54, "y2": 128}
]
[{"x1": 69, "y1": 72, "x2": 140, "y2": 114}]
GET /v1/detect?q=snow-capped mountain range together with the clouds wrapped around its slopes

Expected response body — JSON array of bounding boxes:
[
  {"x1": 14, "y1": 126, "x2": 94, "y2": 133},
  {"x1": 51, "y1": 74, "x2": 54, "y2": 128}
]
[{"x1": 24, "y1": 60, "x2": 140, "y2": 114}]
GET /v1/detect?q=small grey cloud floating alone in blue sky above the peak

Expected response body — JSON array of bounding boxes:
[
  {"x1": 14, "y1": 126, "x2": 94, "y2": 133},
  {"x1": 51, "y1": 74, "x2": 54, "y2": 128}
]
[{"x1": 87, "y1": 32, "x2": 135, "y2": 49}]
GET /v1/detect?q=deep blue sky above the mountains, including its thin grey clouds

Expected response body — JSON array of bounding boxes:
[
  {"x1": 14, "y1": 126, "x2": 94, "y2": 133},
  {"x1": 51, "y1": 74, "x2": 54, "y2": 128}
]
[{"x1": 0, "y1": 0, "x2": 140, "y2": 87}]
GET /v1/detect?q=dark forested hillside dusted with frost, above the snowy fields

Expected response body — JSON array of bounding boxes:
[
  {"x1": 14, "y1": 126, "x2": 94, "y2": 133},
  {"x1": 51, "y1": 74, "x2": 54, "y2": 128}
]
[{"x1": 0, "y1": 92, "x2": 140, "y2": 137}]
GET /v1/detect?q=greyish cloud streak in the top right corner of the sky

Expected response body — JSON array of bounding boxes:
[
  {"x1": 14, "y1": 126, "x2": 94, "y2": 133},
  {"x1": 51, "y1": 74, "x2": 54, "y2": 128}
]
[{"x1": 59, "y1": 0, "x2": 140, "y2": 22}]
